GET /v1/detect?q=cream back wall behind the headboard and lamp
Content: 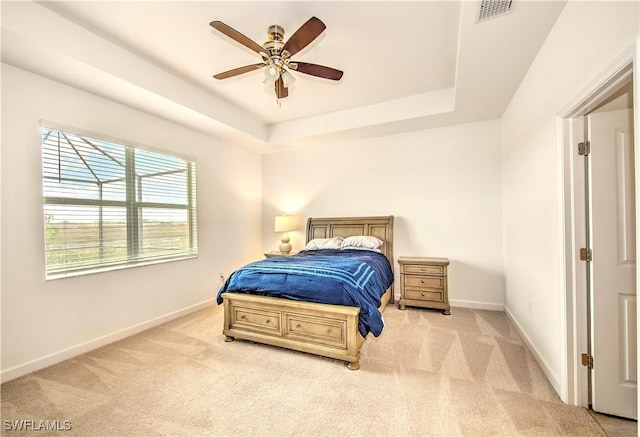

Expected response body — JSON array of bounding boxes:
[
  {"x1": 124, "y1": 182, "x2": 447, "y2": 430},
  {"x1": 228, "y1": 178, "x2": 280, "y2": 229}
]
[{"x1": 263, "y1": 120, "x2": 504, "y2": 310}]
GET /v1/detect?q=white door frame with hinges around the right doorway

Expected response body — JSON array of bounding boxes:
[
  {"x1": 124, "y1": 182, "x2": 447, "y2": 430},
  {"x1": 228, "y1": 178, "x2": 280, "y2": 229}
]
[{"x1": 557, "y1": 44, "x2": 640, "y2": 414}]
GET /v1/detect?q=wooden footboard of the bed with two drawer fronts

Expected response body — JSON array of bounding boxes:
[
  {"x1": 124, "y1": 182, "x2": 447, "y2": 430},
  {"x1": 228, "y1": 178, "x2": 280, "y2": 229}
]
[{"x1": 222, "y1": 290, "x2": 391, "y2": 370}]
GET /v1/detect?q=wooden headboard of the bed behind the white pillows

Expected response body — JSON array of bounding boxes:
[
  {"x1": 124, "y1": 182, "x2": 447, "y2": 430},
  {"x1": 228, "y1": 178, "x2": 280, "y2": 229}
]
[{"x1": 307, "y1": 215, "x2": 395, "y2": 269}]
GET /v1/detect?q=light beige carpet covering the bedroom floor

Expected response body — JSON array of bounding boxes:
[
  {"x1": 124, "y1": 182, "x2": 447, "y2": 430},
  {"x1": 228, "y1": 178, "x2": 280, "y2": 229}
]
[{"x1": 1, "y1": 305, "x2": 605, "y2": 436}]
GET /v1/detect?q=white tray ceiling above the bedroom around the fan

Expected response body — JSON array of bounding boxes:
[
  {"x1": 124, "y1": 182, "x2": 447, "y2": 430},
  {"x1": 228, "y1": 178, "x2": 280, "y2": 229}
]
[{"x1": 2, "y1": 0, "x2": 565, "y2": 152}]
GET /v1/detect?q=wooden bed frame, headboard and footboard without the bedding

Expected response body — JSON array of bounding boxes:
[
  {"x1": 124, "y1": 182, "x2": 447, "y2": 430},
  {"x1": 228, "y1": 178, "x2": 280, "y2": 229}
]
[{"x1": 222, "y1": 216, "x2": 394, "y2": 370}]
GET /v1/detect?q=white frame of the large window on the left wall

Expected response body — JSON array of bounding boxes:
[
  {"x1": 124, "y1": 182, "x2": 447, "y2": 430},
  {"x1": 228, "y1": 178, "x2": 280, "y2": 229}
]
[{"x1": 39, "y1": 120, "x2": 198, "y2": 280}]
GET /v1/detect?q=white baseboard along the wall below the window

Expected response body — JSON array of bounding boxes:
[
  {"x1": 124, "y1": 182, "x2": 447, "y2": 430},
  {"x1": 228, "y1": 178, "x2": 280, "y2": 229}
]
[{"x1": 0, "y1": 299, "x2": 215, "y2": 382}]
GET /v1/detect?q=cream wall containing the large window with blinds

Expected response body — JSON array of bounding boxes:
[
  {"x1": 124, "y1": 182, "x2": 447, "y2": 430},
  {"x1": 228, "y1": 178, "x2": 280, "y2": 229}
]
[{"x1": 1, "y1": 64, "x2": 262, "y2": 379}]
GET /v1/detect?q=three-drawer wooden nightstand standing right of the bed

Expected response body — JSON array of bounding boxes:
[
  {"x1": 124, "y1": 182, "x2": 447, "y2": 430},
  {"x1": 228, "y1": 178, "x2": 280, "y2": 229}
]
[{"x1": 398, "y1": 256, "x2": 451, "y2": 315}]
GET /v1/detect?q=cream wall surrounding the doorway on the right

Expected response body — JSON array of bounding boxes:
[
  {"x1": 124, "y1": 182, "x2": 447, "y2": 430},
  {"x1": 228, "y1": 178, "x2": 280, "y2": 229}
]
[{"x1": 501, "y1": 2, "x2": 640, "y2": 395}]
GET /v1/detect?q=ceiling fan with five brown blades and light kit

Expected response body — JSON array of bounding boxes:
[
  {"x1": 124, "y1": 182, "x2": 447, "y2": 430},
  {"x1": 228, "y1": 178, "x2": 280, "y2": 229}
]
[{"x1": 209, "y1": 17, "x2": 343, "y2": 99}]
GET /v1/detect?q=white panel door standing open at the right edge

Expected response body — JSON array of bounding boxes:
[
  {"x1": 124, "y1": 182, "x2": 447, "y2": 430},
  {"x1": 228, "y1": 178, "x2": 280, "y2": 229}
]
[{"x1": 587, "y1": 109, "x2": 637, "y2": 419}]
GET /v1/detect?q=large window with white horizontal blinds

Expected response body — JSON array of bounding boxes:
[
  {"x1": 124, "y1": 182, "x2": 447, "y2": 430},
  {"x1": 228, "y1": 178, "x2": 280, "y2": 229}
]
[{"x1": 41, "y1": 127, "x2": 198, "y2": 278}]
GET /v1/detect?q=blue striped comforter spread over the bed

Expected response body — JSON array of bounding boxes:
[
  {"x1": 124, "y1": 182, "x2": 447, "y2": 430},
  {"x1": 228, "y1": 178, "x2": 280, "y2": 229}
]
[{"x1": 217, "y1": 249, "x2": 393, "y2": 337}]
